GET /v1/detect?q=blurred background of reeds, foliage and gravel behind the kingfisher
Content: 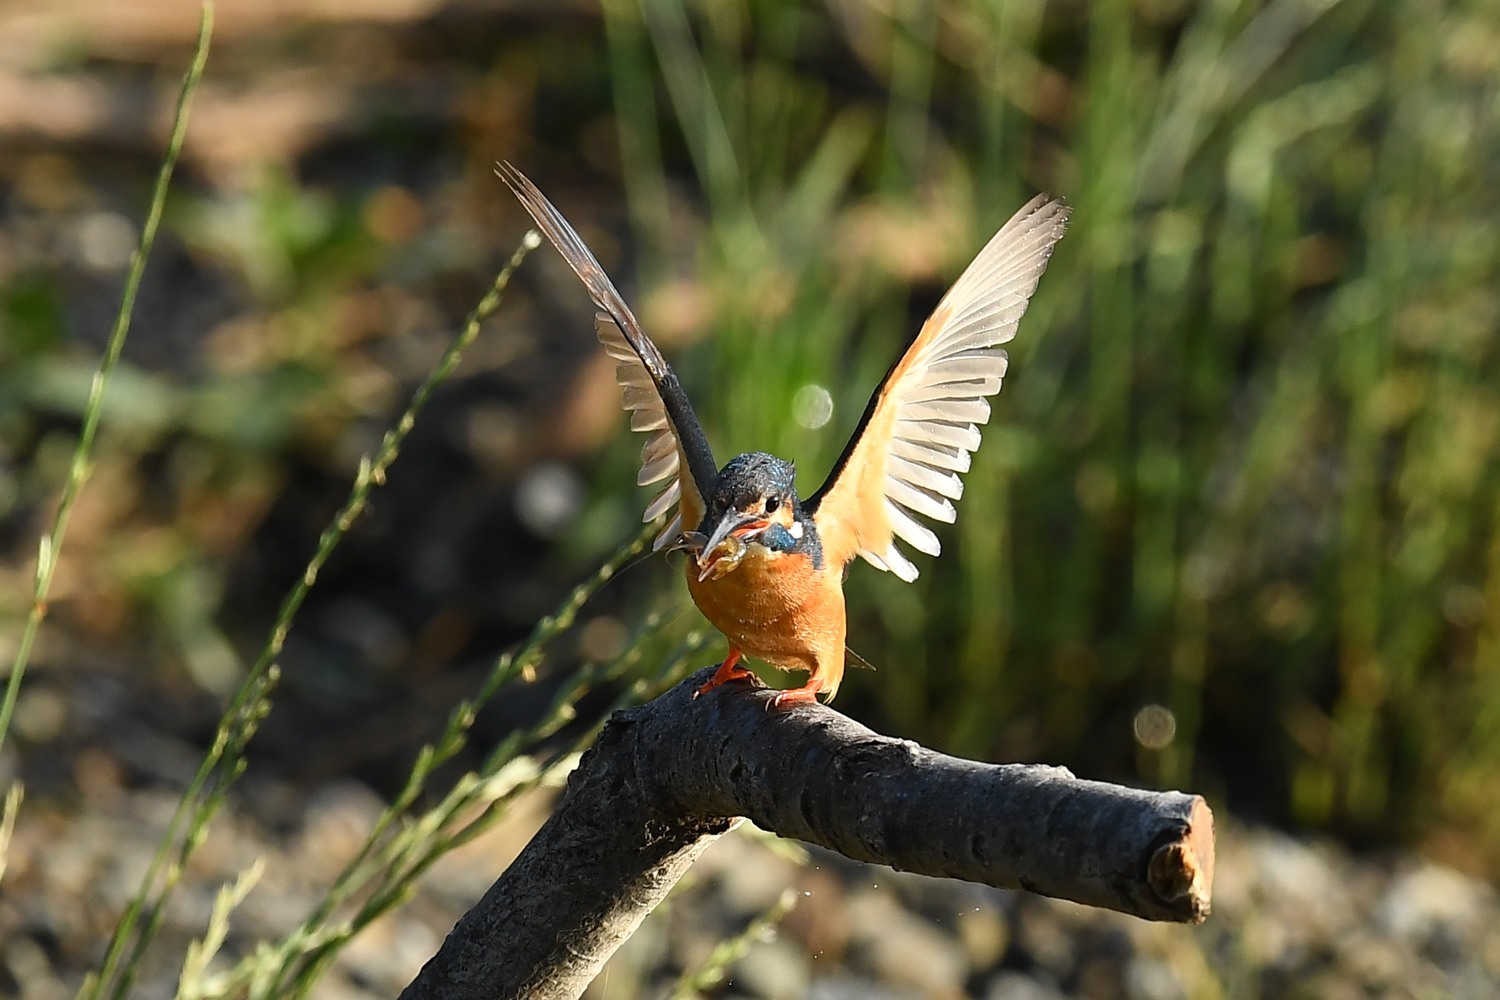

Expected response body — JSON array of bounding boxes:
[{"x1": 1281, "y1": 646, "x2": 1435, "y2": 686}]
[{"x1": 0, "y1": 0, "x2": 1500, "y2": 1000}]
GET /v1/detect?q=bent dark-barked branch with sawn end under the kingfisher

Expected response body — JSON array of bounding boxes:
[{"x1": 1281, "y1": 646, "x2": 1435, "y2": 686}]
[{"x1": 402, "y1": 670, "x2": 1214, "y2": 1000}]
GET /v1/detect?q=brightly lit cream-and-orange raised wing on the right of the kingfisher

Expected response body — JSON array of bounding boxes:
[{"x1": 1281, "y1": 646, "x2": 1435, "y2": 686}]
[{"x1": 806, "y1": 195, "x2": 1068, "y2": 582}]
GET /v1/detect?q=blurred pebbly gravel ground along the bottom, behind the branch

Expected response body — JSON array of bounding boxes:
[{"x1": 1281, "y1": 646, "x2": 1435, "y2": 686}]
[{"x1": 0, "y1": 762, "x2": 1500, "y2": 1000}]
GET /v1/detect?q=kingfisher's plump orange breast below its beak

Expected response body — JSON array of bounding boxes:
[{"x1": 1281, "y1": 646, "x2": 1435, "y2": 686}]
[{"x1": 687, "y1": 544, "x2": 845, "y2": 685}]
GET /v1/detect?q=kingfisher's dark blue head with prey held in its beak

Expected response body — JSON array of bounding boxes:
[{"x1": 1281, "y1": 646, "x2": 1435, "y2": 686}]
[{"x1": 695, "y1": 451, "x2": 801, "y2": 580}]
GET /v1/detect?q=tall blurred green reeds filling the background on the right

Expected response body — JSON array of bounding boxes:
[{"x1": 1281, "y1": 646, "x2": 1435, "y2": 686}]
[{"x1": 591, "y1": 1, "x2": 1500, "y2": 862}]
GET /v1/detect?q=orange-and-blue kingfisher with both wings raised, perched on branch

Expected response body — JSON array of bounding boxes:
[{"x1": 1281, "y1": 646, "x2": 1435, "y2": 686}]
[{"x1": 497, "y1": 162, "x2": 1070, "y2": 709}]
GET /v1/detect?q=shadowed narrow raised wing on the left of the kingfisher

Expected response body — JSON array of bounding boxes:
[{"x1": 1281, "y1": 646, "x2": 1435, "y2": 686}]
[{"x1": 495, "y1": 163, "x2": 719, "y2": 549}]
